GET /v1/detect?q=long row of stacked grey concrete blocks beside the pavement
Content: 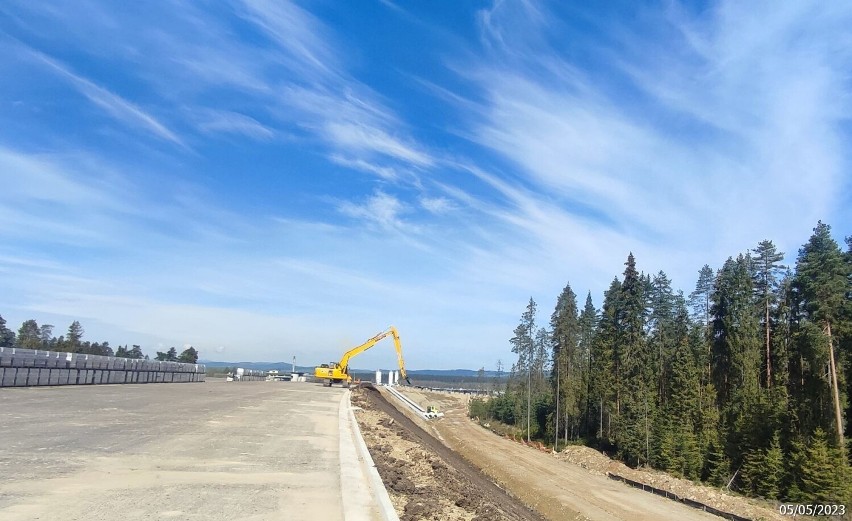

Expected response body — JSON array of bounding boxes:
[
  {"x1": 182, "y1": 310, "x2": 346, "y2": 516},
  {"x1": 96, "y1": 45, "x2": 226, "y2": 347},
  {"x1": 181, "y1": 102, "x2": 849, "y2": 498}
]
[{"x1": 0, "y1": 347, "x2": 207, "y2": 387}]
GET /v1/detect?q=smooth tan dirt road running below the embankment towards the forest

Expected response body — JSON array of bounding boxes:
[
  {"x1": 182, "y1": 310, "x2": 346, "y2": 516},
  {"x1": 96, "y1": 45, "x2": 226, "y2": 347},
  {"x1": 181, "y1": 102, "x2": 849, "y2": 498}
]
[{"x1": 396, "y1": 389, "x2": 720, "y2": 521}]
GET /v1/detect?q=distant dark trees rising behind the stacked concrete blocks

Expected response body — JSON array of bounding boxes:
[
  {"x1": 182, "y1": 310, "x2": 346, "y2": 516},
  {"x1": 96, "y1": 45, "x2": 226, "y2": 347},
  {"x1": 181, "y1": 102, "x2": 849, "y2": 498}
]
[{"x1": 0, "y1": 315, "x2": 198, "y2": 364}]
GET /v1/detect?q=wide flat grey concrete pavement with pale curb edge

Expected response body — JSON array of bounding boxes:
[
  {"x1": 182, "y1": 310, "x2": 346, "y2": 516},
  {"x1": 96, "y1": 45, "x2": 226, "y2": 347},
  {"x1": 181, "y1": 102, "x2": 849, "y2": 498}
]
[{"x1": 0, "y1": 381, "x2": 390, "y2": 521}]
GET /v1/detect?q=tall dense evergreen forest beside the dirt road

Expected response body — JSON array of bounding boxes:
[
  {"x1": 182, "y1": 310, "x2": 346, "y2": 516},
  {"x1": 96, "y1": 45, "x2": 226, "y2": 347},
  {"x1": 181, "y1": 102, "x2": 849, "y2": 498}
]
[{"x1": 471, "y1": 222, "x2": 852, "y2": 505}]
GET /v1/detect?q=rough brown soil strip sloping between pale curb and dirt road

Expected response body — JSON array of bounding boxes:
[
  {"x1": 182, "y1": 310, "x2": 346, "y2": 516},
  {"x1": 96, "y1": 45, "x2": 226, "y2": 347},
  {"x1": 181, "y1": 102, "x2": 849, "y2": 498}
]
[{"x1": 352, "y1": 387, "x2": 542, "y2": 521}]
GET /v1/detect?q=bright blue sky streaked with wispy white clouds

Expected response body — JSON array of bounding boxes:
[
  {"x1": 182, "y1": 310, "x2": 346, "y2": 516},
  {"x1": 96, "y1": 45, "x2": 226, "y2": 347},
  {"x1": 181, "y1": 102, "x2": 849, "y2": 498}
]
[{"x1": 0, "y1": 0, "x2": 852, "y2": 368}]
